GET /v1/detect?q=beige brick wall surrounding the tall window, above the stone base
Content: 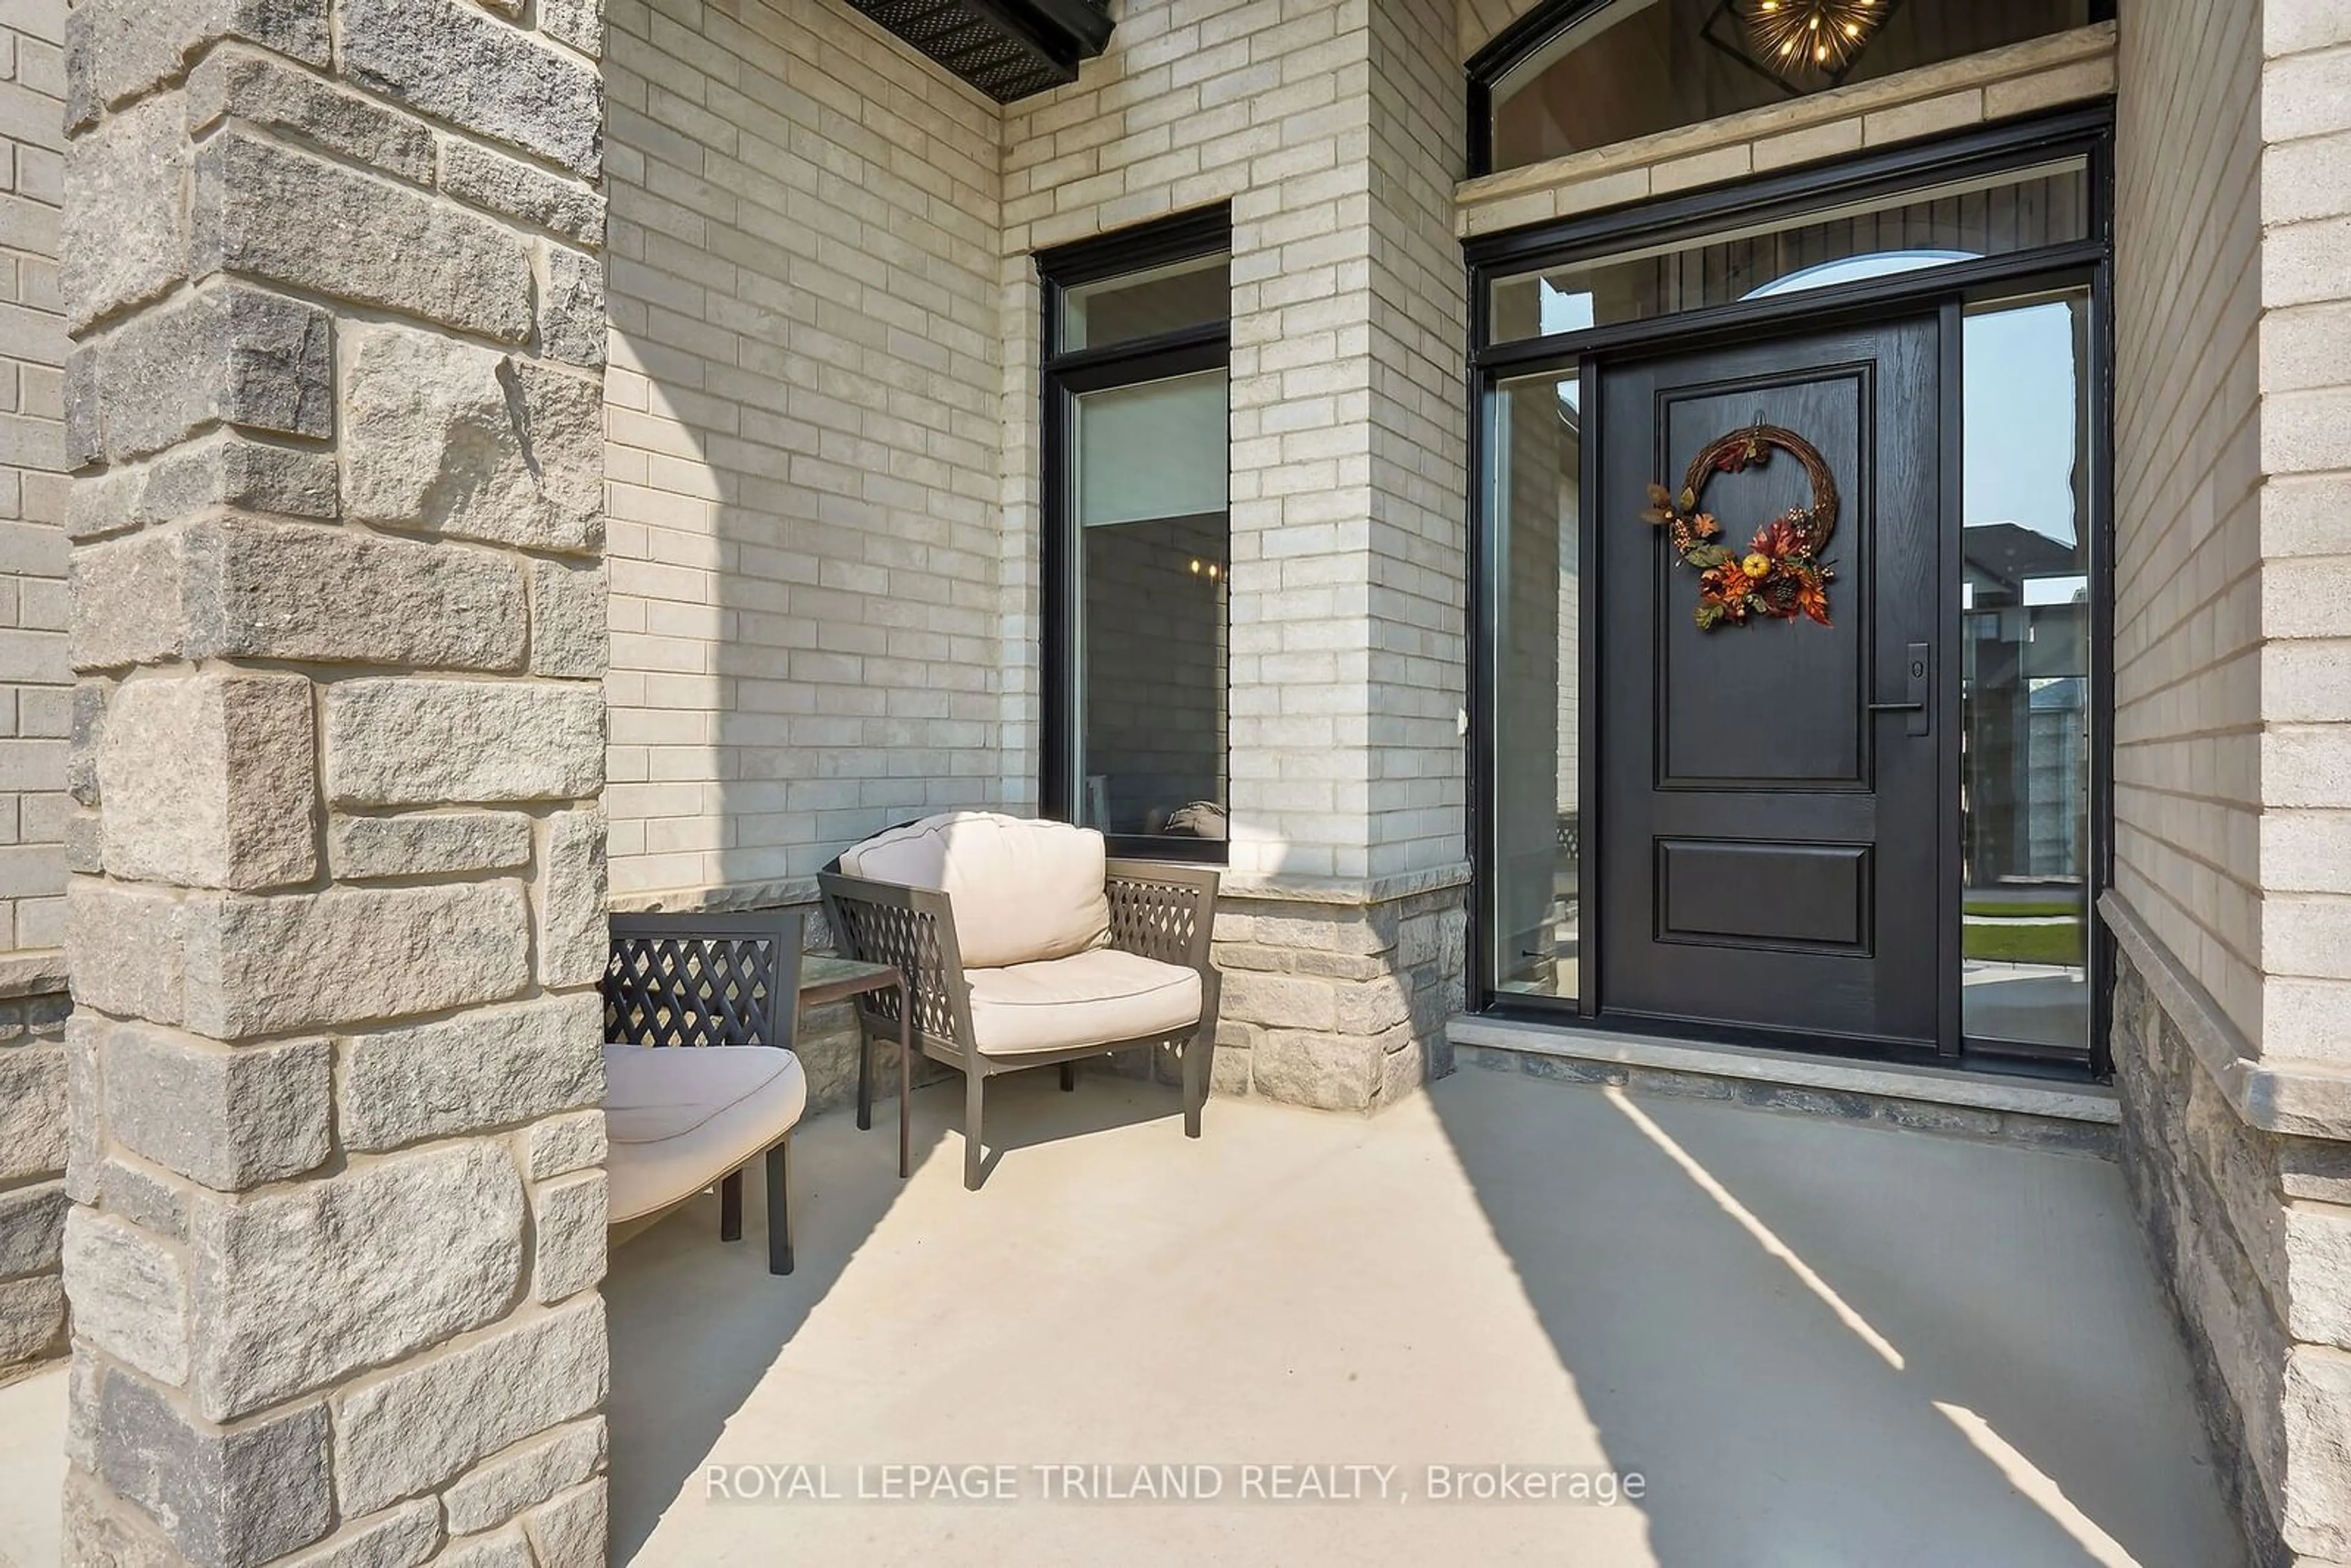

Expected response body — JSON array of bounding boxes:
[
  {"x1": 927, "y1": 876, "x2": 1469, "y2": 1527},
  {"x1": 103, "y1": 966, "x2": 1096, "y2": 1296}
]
[{"x1": 1004, "y1": 0, "x2": 1467, "y2": 879}]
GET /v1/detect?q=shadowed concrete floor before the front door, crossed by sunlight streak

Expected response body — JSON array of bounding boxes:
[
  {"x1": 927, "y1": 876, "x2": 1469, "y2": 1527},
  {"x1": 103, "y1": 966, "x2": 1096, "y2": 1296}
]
[{"x1": 1434, "y1": 1070, "x2": 2243, "y2": 1568}]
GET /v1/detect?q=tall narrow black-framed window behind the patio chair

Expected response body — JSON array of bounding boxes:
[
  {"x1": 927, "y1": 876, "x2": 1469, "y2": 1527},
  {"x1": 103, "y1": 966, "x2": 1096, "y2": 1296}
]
[{"x1": 1039, "y1": 212, "x2": 1232, "y2": 858}]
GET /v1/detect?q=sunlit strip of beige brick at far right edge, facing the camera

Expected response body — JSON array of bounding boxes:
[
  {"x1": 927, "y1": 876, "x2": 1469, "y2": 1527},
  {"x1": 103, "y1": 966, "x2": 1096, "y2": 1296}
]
[{"x1": 2222, "y1": 0, "x2": 2351, "y2": 1067}]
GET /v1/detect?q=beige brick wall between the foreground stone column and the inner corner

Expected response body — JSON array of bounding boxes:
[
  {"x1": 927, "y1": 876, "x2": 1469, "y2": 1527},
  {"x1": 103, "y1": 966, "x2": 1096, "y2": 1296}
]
[{"x1": 607, "y1": 0, "x2": 1018, "y2": 901}]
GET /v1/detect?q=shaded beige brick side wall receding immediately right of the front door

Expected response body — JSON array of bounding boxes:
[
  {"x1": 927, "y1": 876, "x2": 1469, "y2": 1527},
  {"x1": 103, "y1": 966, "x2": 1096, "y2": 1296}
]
[{"x1": 2113, "y1": 0, "x2": 2264, "y2": 1039}]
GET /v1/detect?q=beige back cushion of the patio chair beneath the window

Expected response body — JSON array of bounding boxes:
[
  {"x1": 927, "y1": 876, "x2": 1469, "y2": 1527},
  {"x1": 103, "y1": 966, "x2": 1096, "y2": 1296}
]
[{"x1": 842, "y1": 811, "x2": 1109, "y2": 969}]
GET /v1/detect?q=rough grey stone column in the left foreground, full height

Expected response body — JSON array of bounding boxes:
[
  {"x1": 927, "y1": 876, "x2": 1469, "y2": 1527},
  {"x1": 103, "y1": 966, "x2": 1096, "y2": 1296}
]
[{"x1": 64, "y1": 0, "x2": 607, "y2": 1568}]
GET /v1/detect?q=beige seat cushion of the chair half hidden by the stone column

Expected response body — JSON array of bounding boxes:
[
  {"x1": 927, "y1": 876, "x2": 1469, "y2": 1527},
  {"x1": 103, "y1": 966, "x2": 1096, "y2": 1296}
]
[{"x1": 604, "y1": 1046, "x2": 809, "y2": 1225}]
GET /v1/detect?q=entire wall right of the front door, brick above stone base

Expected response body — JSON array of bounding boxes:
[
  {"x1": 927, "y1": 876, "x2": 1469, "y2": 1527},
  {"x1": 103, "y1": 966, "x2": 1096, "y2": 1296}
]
[{"x1": 2104, "y1": 0, "x2": 2351, "y2": 1566}]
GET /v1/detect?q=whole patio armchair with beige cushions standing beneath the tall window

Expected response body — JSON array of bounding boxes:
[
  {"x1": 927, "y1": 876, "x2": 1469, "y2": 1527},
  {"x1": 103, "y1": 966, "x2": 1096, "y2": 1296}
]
[{"x1": 818, "y1": 811, "x2": 1218, "y2": 1187}]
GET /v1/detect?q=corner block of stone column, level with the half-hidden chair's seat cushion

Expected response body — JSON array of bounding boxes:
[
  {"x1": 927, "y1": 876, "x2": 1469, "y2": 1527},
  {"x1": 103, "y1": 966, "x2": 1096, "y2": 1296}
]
[{"x1": 96, "y1": 1022, "x2": 334, "y2": 1192}]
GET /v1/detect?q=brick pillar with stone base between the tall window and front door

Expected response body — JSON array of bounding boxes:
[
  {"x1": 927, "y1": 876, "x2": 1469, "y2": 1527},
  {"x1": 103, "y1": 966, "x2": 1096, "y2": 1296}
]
[{"x1": 1215, "y1": 0, "x2": 1467, "y2": 1109}]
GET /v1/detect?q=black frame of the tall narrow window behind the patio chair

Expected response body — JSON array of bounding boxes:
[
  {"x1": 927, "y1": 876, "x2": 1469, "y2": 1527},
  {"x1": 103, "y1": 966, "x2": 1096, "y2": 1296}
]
[{"x1": 1035, "y1": 204, "x2": 1232, "y2": 865}]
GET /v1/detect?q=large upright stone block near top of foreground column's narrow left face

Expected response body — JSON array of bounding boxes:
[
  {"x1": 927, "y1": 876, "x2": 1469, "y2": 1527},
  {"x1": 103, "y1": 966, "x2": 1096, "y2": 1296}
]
[{"x1": 59, "y1": 96, "x2": 188, "y2": 331}]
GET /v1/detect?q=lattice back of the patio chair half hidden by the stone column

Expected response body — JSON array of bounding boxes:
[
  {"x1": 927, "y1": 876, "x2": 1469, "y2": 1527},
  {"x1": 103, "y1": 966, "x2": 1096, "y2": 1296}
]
[{"x1": 604, "y1": 910, "x2": 801, "y2": 1051}]
